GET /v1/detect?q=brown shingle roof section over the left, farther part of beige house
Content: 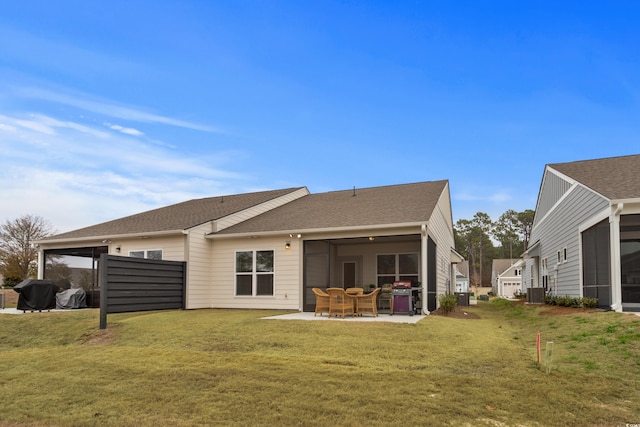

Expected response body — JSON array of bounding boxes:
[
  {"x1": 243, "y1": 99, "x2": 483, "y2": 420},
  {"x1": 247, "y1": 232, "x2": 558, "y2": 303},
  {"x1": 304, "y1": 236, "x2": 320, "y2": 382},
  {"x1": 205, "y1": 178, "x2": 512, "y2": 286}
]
[{"x1": 42, "y1": 187, "x2": 304, "y2": 242}]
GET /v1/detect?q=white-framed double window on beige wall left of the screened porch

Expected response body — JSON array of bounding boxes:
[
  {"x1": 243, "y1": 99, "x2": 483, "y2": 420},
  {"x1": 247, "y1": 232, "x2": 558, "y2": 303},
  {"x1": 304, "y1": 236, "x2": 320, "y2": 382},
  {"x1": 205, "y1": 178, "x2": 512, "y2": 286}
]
[{"x1": 236, "y1": 251, "x2": 274, "y2": 296}]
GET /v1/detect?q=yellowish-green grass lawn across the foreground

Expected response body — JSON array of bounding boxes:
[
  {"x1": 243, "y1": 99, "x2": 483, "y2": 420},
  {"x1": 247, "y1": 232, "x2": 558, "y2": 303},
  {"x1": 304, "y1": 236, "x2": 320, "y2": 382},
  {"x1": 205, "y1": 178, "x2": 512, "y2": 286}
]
[{"x1": 0, "y1": 302, "x2": 640, "y2": 426}]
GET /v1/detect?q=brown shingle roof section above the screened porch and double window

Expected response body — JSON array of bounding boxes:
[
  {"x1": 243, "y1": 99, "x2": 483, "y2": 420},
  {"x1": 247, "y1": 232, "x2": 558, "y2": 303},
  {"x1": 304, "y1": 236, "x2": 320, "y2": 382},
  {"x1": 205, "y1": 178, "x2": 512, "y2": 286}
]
[{"x1": 216, "y1": 180, "x2": 448, "y2": 234}]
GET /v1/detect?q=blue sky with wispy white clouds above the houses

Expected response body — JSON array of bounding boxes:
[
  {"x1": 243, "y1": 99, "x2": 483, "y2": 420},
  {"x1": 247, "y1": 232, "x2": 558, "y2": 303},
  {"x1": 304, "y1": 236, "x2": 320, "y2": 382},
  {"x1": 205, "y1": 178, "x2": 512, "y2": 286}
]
[{"x1": 0, "y1": 0, "x2": 640, "y2": 231}]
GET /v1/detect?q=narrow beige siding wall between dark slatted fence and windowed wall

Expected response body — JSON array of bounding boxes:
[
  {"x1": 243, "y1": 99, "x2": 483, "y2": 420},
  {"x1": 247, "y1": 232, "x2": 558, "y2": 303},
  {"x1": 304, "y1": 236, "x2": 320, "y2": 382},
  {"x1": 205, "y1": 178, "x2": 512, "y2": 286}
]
[{"x1": 187, "y1": 223, "x2": 213, "y2": 309}]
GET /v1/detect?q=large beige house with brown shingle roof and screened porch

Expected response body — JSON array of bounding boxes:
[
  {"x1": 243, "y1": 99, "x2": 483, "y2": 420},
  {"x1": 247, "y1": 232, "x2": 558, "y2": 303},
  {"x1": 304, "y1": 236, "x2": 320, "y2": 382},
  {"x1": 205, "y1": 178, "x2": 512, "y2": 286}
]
[{"x1": 37, "y1": 180, "x2": 462, "y2": 313}]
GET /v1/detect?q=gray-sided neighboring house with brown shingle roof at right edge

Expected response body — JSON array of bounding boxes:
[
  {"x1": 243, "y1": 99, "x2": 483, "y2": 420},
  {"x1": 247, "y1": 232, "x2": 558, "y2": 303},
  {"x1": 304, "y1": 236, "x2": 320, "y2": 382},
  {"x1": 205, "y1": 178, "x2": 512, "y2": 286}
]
[{"x1": 523, "y1": 155, "x2": 640, "y2": 311}]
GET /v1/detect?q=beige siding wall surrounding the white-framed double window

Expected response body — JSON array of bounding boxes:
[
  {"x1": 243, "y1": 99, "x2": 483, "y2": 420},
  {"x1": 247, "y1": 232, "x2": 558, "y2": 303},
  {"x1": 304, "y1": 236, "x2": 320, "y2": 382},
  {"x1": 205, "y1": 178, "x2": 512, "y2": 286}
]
[{"x1": 208, "y1": 236, "x2": 302, "y2": 310}]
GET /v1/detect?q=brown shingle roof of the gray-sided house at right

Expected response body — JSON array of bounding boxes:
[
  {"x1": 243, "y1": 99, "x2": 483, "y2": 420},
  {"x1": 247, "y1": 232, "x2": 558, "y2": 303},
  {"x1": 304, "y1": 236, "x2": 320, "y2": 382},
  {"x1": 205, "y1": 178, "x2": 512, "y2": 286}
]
[{"x1": 549, "y1": 154, "x2": 640, "y2": 200}]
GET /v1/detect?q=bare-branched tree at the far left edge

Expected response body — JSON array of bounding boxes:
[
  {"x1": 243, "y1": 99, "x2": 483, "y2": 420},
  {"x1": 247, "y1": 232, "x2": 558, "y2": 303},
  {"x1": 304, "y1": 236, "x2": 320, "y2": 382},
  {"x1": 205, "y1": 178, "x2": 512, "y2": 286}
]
[{"x1": 0, "y1": 215, "x2": 52, "y2": 284}]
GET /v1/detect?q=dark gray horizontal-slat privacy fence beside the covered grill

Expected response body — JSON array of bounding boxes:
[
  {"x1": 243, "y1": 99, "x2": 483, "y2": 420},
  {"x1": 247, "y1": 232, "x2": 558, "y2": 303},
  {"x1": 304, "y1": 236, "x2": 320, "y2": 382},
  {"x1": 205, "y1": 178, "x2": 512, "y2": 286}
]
[{"x1": 100, "y1": 254, "x2": 187, "y2": 329}]
